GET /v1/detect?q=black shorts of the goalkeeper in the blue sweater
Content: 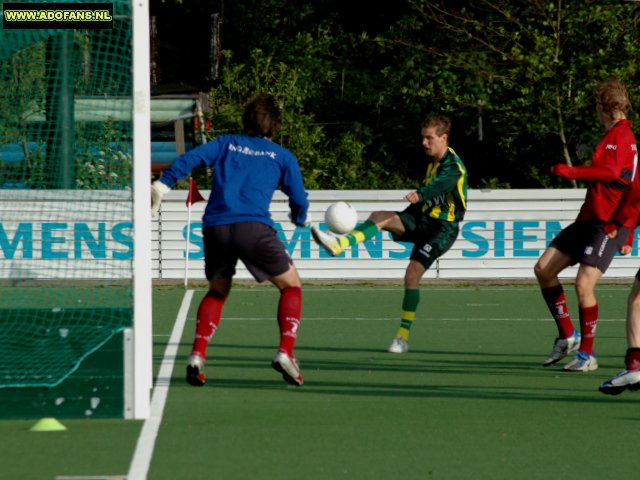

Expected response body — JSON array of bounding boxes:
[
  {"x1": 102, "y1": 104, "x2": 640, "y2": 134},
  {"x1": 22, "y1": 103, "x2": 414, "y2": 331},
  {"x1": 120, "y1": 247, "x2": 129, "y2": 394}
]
[{"x1": 202, "y1": 222, "x2": 293, "y2": 282}]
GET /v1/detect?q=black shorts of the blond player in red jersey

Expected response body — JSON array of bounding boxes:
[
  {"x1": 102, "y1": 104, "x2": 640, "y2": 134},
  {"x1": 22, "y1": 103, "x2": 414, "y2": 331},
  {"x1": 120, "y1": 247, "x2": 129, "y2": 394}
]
[{"x1": 550, "y1": 220, "x2": 629, "y2": 273}]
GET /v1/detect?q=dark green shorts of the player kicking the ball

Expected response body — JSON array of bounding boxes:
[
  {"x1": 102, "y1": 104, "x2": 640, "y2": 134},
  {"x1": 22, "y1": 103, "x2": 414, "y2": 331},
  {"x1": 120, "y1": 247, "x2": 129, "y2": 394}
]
[{"x1": 392, "y1": 205, "x2": 459, "y2": 270}]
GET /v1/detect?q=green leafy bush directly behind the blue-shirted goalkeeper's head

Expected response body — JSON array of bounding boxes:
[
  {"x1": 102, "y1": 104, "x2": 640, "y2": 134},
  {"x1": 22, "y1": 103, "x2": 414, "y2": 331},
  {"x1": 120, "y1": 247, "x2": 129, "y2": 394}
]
[{"x1": 211, "y1": 38, "x2": 410, "y2": 189}]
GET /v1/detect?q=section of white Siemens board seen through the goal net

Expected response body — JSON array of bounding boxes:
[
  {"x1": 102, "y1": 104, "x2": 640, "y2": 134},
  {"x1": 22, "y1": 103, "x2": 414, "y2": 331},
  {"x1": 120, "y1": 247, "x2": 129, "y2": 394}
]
[{"x1": 0, "y1": 190, "x2": 133, "y2": 281}]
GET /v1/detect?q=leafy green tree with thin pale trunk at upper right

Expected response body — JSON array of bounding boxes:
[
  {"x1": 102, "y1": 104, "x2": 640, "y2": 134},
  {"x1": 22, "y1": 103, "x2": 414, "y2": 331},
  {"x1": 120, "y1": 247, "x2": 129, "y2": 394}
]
[{"x1": 377, "y1": 0, "x2": 640, "y2": 186}]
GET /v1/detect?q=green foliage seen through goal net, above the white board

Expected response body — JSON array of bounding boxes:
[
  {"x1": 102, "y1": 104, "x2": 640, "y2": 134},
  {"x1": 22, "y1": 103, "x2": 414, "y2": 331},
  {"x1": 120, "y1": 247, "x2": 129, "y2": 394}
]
[{"x1": 0, "y1": 26, "x2": 132, "y2": 189}]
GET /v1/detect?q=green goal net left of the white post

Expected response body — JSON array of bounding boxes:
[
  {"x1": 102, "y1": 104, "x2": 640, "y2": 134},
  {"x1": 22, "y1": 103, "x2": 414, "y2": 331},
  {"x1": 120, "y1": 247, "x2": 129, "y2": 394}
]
[{"x1": 0, "y1": 0, "x2": 134, "y2": 404}]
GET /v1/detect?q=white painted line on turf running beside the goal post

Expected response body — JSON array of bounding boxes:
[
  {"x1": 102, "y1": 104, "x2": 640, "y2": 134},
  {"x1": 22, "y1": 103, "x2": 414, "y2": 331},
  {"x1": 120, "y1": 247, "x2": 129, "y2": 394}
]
[{"x1": 127, "y1": 290, "x2": 193, "y2": 480}]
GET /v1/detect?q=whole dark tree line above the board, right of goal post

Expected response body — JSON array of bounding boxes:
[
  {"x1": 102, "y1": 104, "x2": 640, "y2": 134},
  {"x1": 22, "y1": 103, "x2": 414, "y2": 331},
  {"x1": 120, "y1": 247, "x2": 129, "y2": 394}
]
[{"x1": 156, "y1": 0, "x2": 640, "y2": 188}]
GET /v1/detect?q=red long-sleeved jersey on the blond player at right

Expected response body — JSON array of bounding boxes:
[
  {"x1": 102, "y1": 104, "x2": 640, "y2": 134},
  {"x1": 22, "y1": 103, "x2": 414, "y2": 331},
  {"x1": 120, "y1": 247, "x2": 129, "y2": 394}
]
[{"x1": 572, "y1": 119, "x2": 638, "y2": 222}]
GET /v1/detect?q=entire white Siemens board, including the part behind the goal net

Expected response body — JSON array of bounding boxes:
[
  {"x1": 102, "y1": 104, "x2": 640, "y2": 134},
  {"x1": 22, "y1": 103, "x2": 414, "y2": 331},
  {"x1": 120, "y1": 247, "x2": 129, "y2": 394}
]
[{"x1": 0, "y1": 190, "x2": 640, "y2": 281}]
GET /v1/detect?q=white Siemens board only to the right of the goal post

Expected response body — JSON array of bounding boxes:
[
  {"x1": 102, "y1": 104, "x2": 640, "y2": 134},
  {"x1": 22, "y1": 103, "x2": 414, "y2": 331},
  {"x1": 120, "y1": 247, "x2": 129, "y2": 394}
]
[{"x1": 153, "y1": 189, "x2": 640, "y2": 280}]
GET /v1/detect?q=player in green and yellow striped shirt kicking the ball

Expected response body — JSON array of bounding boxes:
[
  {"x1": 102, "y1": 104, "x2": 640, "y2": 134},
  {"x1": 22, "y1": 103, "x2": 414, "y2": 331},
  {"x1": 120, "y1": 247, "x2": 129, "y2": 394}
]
[{"x1": 311, "y1": 116, "x2": 467, "y2": 353}]
